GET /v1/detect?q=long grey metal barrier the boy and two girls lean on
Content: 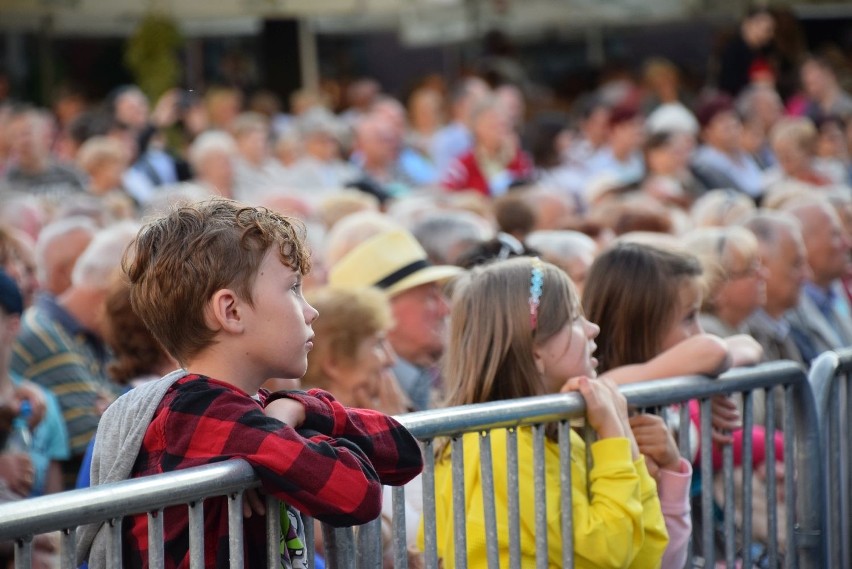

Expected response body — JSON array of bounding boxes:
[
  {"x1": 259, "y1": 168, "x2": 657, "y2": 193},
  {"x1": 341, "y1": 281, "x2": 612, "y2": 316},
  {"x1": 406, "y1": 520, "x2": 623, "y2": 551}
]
[{"x1": 0, "y1": 362, "x2": 828, "y2": 569}]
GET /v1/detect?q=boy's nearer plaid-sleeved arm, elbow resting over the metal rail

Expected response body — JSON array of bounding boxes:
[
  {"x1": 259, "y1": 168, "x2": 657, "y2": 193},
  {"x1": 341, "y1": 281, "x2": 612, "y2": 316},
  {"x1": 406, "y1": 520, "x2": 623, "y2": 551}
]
[{"x1": 167, "y1": 388, "x2": 382, "y2": 526}]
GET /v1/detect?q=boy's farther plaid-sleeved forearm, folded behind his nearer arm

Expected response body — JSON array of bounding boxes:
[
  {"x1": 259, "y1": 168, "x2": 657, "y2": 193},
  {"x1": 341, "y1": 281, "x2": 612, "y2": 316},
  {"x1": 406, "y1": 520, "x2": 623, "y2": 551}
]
[{"x1": 265, "y1": 389, "x2": 423, "y2": 486}]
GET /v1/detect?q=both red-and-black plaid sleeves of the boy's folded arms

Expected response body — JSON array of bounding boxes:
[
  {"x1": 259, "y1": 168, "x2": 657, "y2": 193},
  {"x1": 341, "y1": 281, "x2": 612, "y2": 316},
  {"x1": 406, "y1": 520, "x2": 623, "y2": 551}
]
[{"x1": 148, "y1": 375, "x2": 422, "y2": 526}]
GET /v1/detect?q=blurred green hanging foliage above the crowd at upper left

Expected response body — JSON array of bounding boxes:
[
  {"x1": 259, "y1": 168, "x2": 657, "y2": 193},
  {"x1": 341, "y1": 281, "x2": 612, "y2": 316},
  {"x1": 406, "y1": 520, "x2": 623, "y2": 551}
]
[{"x1": 124, "y1": 14, "x2": 183, "y2": 102}]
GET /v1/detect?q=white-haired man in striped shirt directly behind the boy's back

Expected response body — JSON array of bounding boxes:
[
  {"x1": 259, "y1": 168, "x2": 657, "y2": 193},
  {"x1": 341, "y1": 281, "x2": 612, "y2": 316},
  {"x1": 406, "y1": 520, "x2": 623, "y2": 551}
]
[{"x1": 11, "y1": 222, "x2": 138, "y2": 488}]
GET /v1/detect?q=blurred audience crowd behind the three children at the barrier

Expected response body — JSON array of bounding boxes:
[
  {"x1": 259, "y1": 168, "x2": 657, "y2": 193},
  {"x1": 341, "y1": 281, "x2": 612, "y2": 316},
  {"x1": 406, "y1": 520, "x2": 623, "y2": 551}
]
[{"x1": 0, "y1": 2, "x2": 852, "y2": 564}]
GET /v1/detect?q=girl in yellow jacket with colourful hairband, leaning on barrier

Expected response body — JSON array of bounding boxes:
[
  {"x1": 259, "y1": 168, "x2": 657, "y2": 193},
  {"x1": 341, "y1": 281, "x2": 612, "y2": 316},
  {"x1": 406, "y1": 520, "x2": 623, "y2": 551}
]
[{"x1": 420, "y1": 258, "x2": 668, "y2": 569}]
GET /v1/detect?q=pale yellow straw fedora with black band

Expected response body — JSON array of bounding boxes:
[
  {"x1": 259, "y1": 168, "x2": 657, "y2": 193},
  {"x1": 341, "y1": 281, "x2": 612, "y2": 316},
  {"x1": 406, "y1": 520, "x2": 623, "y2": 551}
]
[{"x1": 328, "y1": 230, "x2": 462, "y2": 296}]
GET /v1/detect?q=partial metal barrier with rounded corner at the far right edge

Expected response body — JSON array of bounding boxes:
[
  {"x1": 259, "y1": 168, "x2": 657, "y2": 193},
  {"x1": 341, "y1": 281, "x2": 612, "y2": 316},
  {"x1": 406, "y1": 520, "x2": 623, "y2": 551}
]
[{"x1": 809, "y1": 348, "x2": 852, "y2": 567}]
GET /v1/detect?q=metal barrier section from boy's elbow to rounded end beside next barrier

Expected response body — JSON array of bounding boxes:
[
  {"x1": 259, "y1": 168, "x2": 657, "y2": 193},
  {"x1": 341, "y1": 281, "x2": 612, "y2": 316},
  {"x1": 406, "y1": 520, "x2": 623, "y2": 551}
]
[{"x1": 394, "y1": 362, "x2": 824, "y2": 568}]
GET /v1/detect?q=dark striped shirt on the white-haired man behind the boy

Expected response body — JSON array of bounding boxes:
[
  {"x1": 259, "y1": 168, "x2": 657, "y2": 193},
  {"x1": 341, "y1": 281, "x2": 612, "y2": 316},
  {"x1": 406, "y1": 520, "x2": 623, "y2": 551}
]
[{"x1": 12, "y1": 295, "x2": 117, "y2": 456}]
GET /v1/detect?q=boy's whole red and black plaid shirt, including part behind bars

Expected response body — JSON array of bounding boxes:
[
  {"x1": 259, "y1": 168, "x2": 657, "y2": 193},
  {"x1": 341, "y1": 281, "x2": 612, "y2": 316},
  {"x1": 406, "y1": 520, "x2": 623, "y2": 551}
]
[{"x1": 124, "y1": 375, "x2": 423, "y2": 569}]
